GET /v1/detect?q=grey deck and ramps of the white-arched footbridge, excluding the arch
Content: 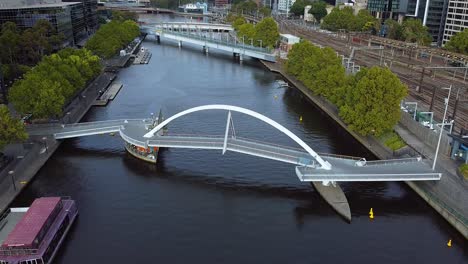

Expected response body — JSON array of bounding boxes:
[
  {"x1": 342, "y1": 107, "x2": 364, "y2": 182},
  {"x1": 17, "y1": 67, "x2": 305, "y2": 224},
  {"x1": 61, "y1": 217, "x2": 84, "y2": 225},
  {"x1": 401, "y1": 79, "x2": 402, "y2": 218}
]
[{"x1": 28, "y1": 119, "x2": 441, "y2": 182}]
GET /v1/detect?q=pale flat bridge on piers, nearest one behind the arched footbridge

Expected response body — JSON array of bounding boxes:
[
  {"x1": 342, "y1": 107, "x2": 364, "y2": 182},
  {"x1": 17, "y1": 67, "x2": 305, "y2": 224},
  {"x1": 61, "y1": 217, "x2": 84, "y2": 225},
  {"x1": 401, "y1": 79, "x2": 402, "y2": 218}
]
[{"x1": 140, "y1": 23, "x2": 276, "y2": 62}]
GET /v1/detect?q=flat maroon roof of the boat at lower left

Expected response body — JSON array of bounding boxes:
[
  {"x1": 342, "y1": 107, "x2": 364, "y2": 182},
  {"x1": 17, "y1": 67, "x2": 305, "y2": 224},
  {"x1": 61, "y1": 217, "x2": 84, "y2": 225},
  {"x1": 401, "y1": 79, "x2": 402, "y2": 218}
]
[{"x1": 2, "y1": 197, "x2": 61, "y2": 247}]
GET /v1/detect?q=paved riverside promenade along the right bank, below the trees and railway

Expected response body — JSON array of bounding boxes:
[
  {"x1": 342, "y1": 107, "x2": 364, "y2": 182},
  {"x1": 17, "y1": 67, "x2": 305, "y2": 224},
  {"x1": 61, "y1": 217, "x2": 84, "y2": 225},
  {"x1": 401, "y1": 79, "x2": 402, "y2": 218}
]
[{"x1": 261, "y1": 61, "x2": 468, "y2": 239}]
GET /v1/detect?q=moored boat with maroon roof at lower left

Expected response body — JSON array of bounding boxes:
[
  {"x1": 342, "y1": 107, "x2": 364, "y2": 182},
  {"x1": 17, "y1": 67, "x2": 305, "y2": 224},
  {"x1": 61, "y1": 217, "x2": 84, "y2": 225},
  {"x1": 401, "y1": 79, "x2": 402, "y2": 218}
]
[{"x1": 0, "y1": 197, "x2": 78, "y2": 264}]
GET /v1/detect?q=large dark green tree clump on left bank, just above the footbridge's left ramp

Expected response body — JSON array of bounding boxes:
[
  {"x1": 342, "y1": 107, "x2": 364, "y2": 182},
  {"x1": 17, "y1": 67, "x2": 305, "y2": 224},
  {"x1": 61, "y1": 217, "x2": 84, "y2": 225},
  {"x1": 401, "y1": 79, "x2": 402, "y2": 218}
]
[{"x1": 9, "y1": 48, "x2": 101, "y2": 118}]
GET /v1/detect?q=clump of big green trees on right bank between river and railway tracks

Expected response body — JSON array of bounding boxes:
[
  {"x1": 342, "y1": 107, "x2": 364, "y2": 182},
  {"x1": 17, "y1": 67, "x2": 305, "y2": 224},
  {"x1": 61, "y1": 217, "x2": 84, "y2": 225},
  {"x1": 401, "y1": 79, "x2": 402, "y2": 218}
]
[{"x1": 286, "y1": 41, "x2": 407, "y2": 136}]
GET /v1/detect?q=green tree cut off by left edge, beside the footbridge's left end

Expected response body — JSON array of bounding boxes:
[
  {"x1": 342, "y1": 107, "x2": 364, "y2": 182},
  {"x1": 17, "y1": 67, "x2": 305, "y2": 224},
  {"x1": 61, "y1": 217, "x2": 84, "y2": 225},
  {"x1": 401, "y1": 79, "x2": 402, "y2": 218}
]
[{"x1": 0, "y1": 105, "x2": 28, "y2": 150}]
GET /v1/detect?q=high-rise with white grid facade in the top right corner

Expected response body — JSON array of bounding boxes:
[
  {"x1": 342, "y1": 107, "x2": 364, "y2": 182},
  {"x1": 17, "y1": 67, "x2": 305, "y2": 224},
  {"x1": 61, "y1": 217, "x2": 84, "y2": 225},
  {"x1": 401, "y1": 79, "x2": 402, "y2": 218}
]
[{"x1": 442, "y1": 0, "x2": 468, "y2": 45}]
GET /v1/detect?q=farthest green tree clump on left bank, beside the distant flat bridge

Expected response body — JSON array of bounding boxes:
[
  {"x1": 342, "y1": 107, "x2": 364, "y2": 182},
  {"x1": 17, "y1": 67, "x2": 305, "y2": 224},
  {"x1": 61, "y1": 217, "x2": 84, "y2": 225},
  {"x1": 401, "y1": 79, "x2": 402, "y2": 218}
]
[{"x1": 86, "y1": 20, "x2": 140, "y2": 58}]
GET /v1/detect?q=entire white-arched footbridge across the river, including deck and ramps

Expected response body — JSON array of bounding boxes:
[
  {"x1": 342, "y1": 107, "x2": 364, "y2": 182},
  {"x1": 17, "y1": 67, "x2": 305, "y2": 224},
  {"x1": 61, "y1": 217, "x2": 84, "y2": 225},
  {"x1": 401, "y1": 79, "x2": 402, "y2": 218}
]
[{"x1": 28, "y1": 105, "x2": 441, "y2": 185}]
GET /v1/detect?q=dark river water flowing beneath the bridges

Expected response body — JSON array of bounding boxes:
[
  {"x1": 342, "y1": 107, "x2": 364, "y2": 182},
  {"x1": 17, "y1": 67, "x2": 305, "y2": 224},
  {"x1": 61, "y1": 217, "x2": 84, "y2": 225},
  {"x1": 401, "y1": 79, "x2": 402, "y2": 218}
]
[{"x1": 14, "y1": 14, "x2": 468, "y2": 264}]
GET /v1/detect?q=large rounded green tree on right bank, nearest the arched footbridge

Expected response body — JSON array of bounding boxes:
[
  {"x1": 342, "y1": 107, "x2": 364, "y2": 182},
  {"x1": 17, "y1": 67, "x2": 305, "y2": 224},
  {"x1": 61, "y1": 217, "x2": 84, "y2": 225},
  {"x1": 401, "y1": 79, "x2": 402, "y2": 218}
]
[{"x1": 340, "y1": 67, "x2": 408, "y2": 136}]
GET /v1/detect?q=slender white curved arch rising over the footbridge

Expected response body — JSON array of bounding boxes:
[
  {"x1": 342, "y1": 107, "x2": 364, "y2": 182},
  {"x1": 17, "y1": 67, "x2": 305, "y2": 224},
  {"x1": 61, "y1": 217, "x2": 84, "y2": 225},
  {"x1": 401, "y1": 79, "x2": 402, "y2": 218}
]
[{"x1": 143, "y1": 104, "x2": 331, "y2": 170}]
